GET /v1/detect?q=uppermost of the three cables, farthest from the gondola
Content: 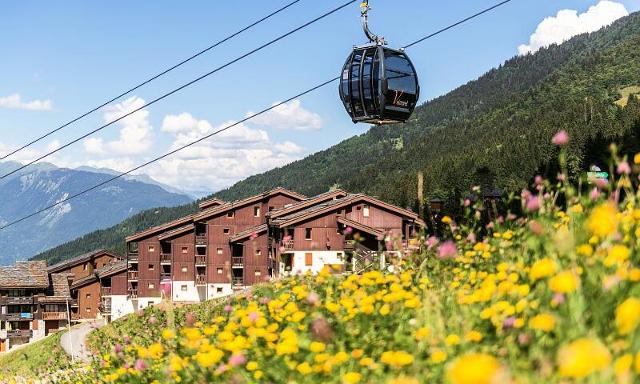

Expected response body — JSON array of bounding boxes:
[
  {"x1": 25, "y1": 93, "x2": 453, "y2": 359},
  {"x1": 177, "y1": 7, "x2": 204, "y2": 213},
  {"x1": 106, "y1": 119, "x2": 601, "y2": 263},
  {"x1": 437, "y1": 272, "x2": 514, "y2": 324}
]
[{"x1": 0, "y1": 0, "x2": 302, "y2": 160}]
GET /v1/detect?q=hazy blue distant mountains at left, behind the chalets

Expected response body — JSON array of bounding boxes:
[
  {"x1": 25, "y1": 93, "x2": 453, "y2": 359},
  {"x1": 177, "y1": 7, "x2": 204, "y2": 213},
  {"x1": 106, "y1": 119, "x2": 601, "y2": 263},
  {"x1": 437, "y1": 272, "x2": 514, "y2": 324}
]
[{"x1": 0, "y1": 162, "x2": 193, "y2": 265}]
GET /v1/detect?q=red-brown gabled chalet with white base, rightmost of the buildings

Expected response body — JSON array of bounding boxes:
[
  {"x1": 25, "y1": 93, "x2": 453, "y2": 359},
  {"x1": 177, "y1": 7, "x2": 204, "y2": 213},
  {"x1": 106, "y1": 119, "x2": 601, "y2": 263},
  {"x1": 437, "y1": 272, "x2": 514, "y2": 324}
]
[{"x1": 268, "y1": 194, "x2": 425, "y2": 273}]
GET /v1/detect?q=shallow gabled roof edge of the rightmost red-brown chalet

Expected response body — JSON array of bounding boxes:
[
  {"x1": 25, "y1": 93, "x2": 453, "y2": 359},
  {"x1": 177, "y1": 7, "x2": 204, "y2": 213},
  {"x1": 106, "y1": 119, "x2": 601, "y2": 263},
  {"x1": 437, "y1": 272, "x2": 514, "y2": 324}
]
[{"x1": 273, "y1": 194, "x2": 424, "y2": 227}]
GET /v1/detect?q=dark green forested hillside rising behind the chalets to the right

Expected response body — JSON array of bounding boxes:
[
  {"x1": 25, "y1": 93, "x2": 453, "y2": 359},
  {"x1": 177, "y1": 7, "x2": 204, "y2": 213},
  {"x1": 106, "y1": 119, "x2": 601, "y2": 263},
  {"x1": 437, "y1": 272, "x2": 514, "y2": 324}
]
[{"x1": 37, "y1": 13, "x2": 640, "y2": 259}]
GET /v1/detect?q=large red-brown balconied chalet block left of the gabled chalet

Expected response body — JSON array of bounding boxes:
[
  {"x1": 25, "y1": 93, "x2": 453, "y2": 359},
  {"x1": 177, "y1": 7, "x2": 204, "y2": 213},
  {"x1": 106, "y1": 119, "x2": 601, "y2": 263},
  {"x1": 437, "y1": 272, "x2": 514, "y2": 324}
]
[{"x1": 126, "y1": 188, "x2": 305, "y2": 310}]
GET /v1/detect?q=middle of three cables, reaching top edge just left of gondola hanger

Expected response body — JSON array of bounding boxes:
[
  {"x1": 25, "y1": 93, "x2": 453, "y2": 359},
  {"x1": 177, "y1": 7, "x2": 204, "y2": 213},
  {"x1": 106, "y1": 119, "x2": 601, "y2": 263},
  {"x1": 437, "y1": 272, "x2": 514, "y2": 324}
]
[{"x1": 0, "y1": 0, "x2": 359, "y2": 180}]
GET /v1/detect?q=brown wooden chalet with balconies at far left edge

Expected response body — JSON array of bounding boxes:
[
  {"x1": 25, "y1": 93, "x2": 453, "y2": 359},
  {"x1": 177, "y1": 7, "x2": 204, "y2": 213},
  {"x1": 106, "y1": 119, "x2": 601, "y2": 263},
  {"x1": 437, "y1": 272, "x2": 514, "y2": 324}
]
[{"x1": 0, "y1": 261, "x2": 72, "y2": 352}]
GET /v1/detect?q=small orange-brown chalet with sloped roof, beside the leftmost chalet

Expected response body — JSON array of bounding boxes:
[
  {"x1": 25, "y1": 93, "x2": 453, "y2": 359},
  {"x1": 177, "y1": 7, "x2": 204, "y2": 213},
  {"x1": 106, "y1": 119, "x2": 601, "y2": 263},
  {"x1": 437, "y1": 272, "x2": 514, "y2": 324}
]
[{"x1": 47, "y1": 250, "x2": 121, "y2": 321}]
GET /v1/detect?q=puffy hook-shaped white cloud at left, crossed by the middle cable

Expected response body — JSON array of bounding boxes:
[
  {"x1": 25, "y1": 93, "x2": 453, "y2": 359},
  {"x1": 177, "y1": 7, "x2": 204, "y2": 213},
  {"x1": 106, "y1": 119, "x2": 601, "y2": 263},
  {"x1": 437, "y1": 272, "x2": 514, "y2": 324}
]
[{"x1": 83, "y1": 96, "x2": 153, "y2": 155}]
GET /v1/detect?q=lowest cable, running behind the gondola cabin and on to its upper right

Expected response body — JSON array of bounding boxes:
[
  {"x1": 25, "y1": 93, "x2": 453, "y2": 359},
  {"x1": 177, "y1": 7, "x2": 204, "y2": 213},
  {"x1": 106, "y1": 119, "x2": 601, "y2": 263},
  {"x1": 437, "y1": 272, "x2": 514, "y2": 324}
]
[{"x1": 0, "y1": 0, "x2": 510, "y2": 231}]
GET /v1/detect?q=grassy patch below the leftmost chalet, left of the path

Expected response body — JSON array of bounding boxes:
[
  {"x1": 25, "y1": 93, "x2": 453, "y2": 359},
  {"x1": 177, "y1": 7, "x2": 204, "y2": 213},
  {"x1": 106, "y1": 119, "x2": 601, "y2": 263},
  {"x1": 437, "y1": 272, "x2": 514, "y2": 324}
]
[{"x1": 0, "y1": 332, "x2": 71, "y2": 382}]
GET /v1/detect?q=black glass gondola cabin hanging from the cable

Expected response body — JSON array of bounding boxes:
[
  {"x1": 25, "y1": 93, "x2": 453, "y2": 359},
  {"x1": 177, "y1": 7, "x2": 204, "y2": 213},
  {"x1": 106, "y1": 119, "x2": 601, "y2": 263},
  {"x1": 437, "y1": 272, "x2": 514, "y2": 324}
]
[{"x1": 340, "y1": 44, "x2": 420, "y2": 125}]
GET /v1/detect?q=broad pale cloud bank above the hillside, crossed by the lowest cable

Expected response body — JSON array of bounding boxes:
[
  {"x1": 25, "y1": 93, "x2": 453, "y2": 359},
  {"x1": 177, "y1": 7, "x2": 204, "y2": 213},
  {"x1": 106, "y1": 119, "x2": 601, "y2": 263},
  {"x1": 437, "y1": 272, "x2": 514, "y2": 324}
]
[{"x1": 145, "y1": 113, "x2": 303, "y2": 191}]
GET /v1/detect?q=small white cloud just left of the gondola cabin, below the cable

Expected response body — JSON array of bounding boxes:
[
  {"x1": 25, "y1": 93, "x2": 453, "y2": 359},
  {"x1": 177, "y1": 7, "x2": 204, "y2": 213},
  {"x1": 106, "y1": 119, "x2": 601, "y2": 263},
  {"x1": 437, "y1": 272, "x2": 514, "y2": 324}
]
[{"x1": 247, "y1": 100, "x2": 322, "y2": 131}]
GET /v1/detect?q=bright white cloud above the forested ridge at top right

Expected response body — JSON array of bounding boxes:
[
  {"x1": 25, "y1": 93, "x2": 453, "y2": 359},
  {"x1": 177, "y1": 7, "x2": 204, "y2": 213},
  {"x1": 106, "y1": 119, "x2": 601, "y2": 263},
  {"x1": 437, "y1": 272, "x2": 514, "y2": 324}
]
[{"x1": 518, "y1": 0, "x2": 629, "y2": 55}]
